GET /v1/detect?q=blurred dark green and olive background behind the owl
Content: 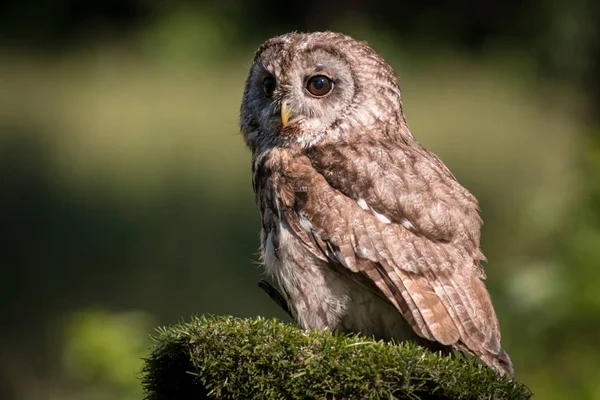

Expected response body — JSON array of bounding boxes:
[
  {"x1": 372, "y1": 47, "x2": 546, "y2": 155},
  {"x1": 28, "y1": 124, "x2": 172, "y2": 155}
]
[{"x1": 0, "y1": 0, "x2": 600, "y2": 400}]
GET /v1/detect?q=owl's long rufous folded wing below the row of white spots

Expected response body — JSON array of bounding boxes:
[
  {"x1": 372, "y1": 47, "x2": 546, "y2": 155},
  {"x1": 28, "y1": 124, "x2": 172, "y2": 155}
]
[{"x1": 278, "y1": 147, "x2": 510, "y2": 372}]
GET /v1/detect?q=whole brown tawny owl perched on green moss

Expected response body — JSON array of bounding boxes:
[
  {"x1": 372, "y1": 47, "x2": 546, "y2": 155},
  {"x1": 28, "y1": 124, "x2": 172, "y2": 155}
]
[{"x1": 240, "y1": 32, "x2": 512, "y2": 375}]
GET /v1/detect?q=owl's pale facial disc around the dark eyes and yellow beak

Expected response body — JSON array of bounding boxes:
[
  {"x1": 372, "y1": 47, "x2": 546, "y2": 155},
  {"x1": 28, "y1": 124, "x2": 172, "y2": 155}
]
[{"x1": 241, "y1": 39, "x2": 358, "y2": 146}]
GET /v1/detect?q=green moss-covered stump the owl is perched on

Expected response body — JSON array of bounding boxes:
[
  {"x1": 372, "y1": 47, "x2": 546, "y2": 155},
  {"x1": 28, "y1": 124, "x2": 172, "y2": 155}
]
[{"x1": 143, "y1": 317, "x2": 532, "y2": 400}]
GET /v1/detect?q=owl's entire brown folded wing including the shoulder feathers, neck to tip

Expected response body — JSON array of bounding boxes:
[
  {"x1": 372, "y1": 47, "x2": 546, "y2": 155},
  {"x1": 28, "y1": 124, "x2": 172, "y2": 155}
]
[{"x1": 268, "y1": 143, "x2": 511, "y2": 373}]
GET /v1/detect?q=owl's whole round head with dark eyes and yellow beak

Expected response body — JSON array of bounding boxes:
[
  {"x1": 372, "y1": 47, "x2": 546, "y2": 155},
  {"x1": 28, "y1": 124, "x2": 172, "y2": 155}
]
[{"x1": 240, "y1": 32, "x2": 404, "y2": 149}]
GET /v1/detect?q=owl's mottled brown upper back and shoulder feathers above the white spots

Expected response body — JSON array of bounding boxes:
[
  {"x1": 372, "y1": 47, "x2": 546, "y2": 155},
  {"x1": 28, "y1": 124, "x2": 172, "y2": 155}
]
[{"x1": 307, "y1": 140, "x2": 483, "y2": 257}]
